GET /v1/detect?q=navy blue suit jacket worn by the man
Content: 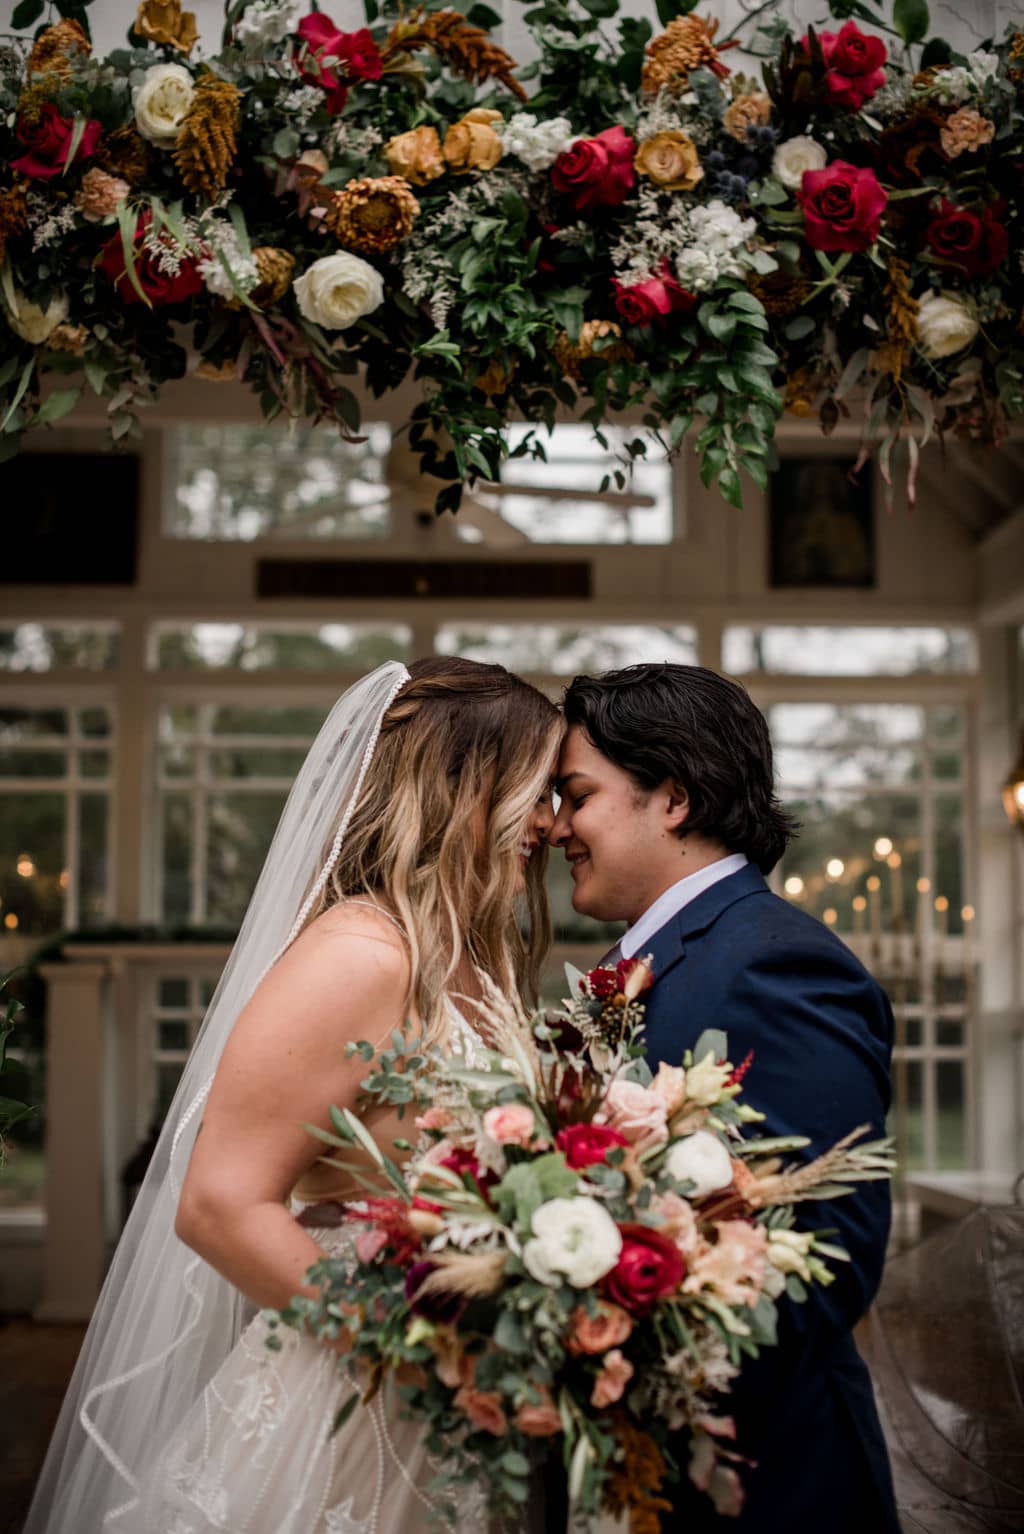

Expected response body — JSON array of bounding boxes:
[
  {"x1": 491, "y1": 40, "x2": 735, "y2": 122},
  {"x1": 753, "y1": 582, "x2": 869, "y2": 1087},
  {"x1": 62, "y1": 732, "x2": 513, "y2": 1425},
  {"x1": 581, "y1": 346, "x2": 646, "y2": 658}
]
[{"x1": 642, "y1": 867, "x2": 900, "y2": 1534}]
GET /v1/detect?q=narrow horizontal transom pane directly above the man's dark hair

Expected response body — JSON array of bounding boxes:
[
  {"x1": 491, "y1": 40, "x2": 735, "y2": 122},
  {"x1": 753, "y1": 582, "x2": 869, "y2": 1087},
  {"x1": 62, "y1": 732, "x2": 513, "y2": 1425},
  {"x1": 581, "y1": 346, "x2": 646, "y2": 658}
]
[{"x1": 434, "y1": 623, "x2": 697, "y2": 676}]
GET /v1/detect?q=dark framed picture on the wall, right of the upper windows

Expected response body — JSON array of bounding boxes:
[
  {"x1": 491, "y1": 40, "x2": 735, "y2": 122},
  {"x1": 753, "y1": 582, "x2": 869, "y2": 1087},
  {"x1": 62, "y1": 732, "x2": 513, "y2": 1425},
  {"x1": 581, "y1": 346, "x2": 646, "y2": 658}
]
[{"x1": 768, "y1": 457, "x2": 877, "y2": 588}]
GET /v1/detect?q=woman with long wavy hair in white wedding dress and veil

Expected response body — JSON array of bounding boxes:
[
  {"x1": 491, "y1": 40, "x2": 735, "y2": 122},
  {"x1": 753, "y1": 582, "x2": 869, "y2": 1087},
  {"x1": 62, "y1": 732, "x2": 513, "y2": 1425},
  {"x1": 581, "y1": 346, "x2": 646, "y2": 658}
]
[{"x1": 25, "y1": 658, "x2": 561, "y2": 1534}]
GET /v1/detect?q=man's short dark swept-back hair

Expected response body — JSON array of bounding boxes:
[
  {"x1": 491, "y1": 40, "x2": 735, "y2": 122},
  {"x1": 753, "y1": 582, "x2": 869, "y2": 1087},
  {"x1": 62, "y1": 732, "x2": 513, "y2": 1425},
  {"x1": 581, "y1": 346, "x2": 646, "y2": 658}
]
[{"x1": 563, "y1": 661, "x2": 797, "y2": 873}]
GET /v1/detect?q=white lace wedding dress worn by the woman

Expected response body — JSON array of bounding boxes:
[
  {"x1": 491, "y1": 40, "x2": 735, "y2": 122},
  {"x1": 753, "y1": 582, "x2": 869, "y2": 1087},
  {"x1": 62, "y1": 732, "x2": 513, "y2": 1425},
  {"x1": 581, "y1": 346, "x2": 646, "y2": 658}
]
[{"x1": 132, "y1": 1008, "x2": 496, "y2": 1534}]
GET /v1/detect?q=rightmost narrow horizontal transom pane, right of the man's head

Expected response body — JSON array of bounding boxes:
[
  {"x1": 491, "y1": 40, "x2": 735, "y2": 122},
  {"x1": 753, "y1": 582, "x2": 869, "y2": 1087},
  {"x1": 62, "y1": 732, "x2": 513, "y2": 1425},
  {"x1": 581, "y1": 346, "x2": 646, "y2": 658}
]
[{"x1": 722, "y1": 624, "x2": 978, "y2": 676}]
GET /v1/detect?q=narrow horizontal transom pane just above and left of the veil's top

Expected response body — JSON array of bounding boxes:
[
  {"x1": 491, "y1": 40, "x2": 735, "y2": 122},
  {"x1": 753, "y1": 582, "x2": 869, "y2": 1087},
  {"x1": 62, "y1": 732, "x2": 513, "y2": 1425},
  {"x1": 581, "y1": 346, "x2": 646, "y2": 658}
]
[{"x1": 155, "y1": 623, "x2": 412, "y2": 670}]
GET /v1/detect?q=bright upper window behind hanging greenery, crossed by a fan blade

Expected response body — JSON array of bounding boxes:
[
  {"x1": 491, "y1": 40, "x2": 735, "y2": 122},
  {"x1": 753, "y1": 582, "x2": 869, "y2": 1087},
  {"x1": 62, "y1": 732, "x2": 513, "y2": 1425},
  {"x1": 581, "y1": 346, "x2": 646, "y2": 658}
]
[{"x1": 455, "y1": 423, "x2": 673, "y2": 546}]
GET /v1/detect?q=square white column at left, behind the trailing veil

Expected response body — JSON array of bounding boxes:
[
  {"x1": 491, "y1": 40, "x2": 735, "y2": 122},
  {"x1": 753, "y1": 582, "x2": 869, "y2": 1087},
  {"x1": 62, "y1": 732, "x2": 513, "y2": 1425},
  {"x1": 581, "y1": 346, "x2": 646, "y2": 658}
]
[{"x1": 35, "y1": 962, "x2": 110, "y2": 1321}]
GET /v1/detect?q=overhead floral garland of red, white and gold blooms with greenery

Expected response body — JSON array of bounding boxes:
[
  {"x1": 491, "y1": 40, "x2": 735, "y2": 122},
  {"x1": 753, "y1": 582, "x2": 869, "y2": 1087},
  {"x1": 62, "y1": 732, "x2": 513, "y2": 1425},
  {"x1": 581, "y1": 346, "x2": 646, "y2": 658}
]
[{"x1": 0, "y1": 0, "x2": 1024, "y2": 509}]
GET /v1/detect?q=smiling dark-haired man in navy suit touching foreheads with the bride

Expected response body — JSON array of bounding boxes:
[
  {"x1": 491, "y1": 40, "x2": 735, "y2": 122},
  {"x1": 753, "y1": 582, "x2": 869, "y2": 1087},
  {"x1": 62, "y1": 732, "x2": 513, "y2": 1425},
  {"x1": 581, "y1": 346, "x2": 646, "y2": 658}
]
[{"x1": 549, "y1": 664, "x2": 900, "y2": 1534}]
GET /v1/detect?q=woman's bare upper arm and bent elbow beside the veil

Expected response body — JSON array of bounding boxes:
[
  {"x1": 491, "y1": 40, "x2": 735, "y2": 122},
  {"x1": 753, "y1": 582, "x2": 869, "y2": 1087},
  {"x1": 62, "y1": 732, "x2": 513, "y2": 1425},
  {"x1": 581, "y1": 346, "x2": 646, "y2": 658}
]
[{"x1": 175, "y1": 910, "x2": 409, "y2": 1309}]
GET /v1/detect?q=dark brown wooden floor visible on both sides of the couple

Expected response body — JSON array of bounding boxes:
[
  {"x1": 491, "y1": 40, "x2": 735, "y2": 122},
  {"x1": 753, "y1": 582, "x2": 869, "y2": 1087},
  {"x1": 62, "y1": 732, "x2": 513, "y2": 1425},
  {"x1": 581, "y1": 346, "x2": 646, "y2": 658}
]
[{"x1": 0, "y1": 1319, "x2": 1006, "y2": 1534}]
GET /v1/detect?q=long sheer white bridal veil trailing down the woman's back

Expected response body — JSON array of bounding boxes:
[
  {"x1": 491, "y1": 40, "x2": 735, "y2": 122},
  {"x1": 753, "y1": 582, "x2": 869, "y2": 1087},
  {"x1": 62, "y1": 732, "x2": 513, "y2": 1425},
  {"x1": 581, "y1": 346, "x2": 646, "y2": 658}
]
[{"x1": 25, "y1": 661, "x2": 409, "y2": 1534}]
